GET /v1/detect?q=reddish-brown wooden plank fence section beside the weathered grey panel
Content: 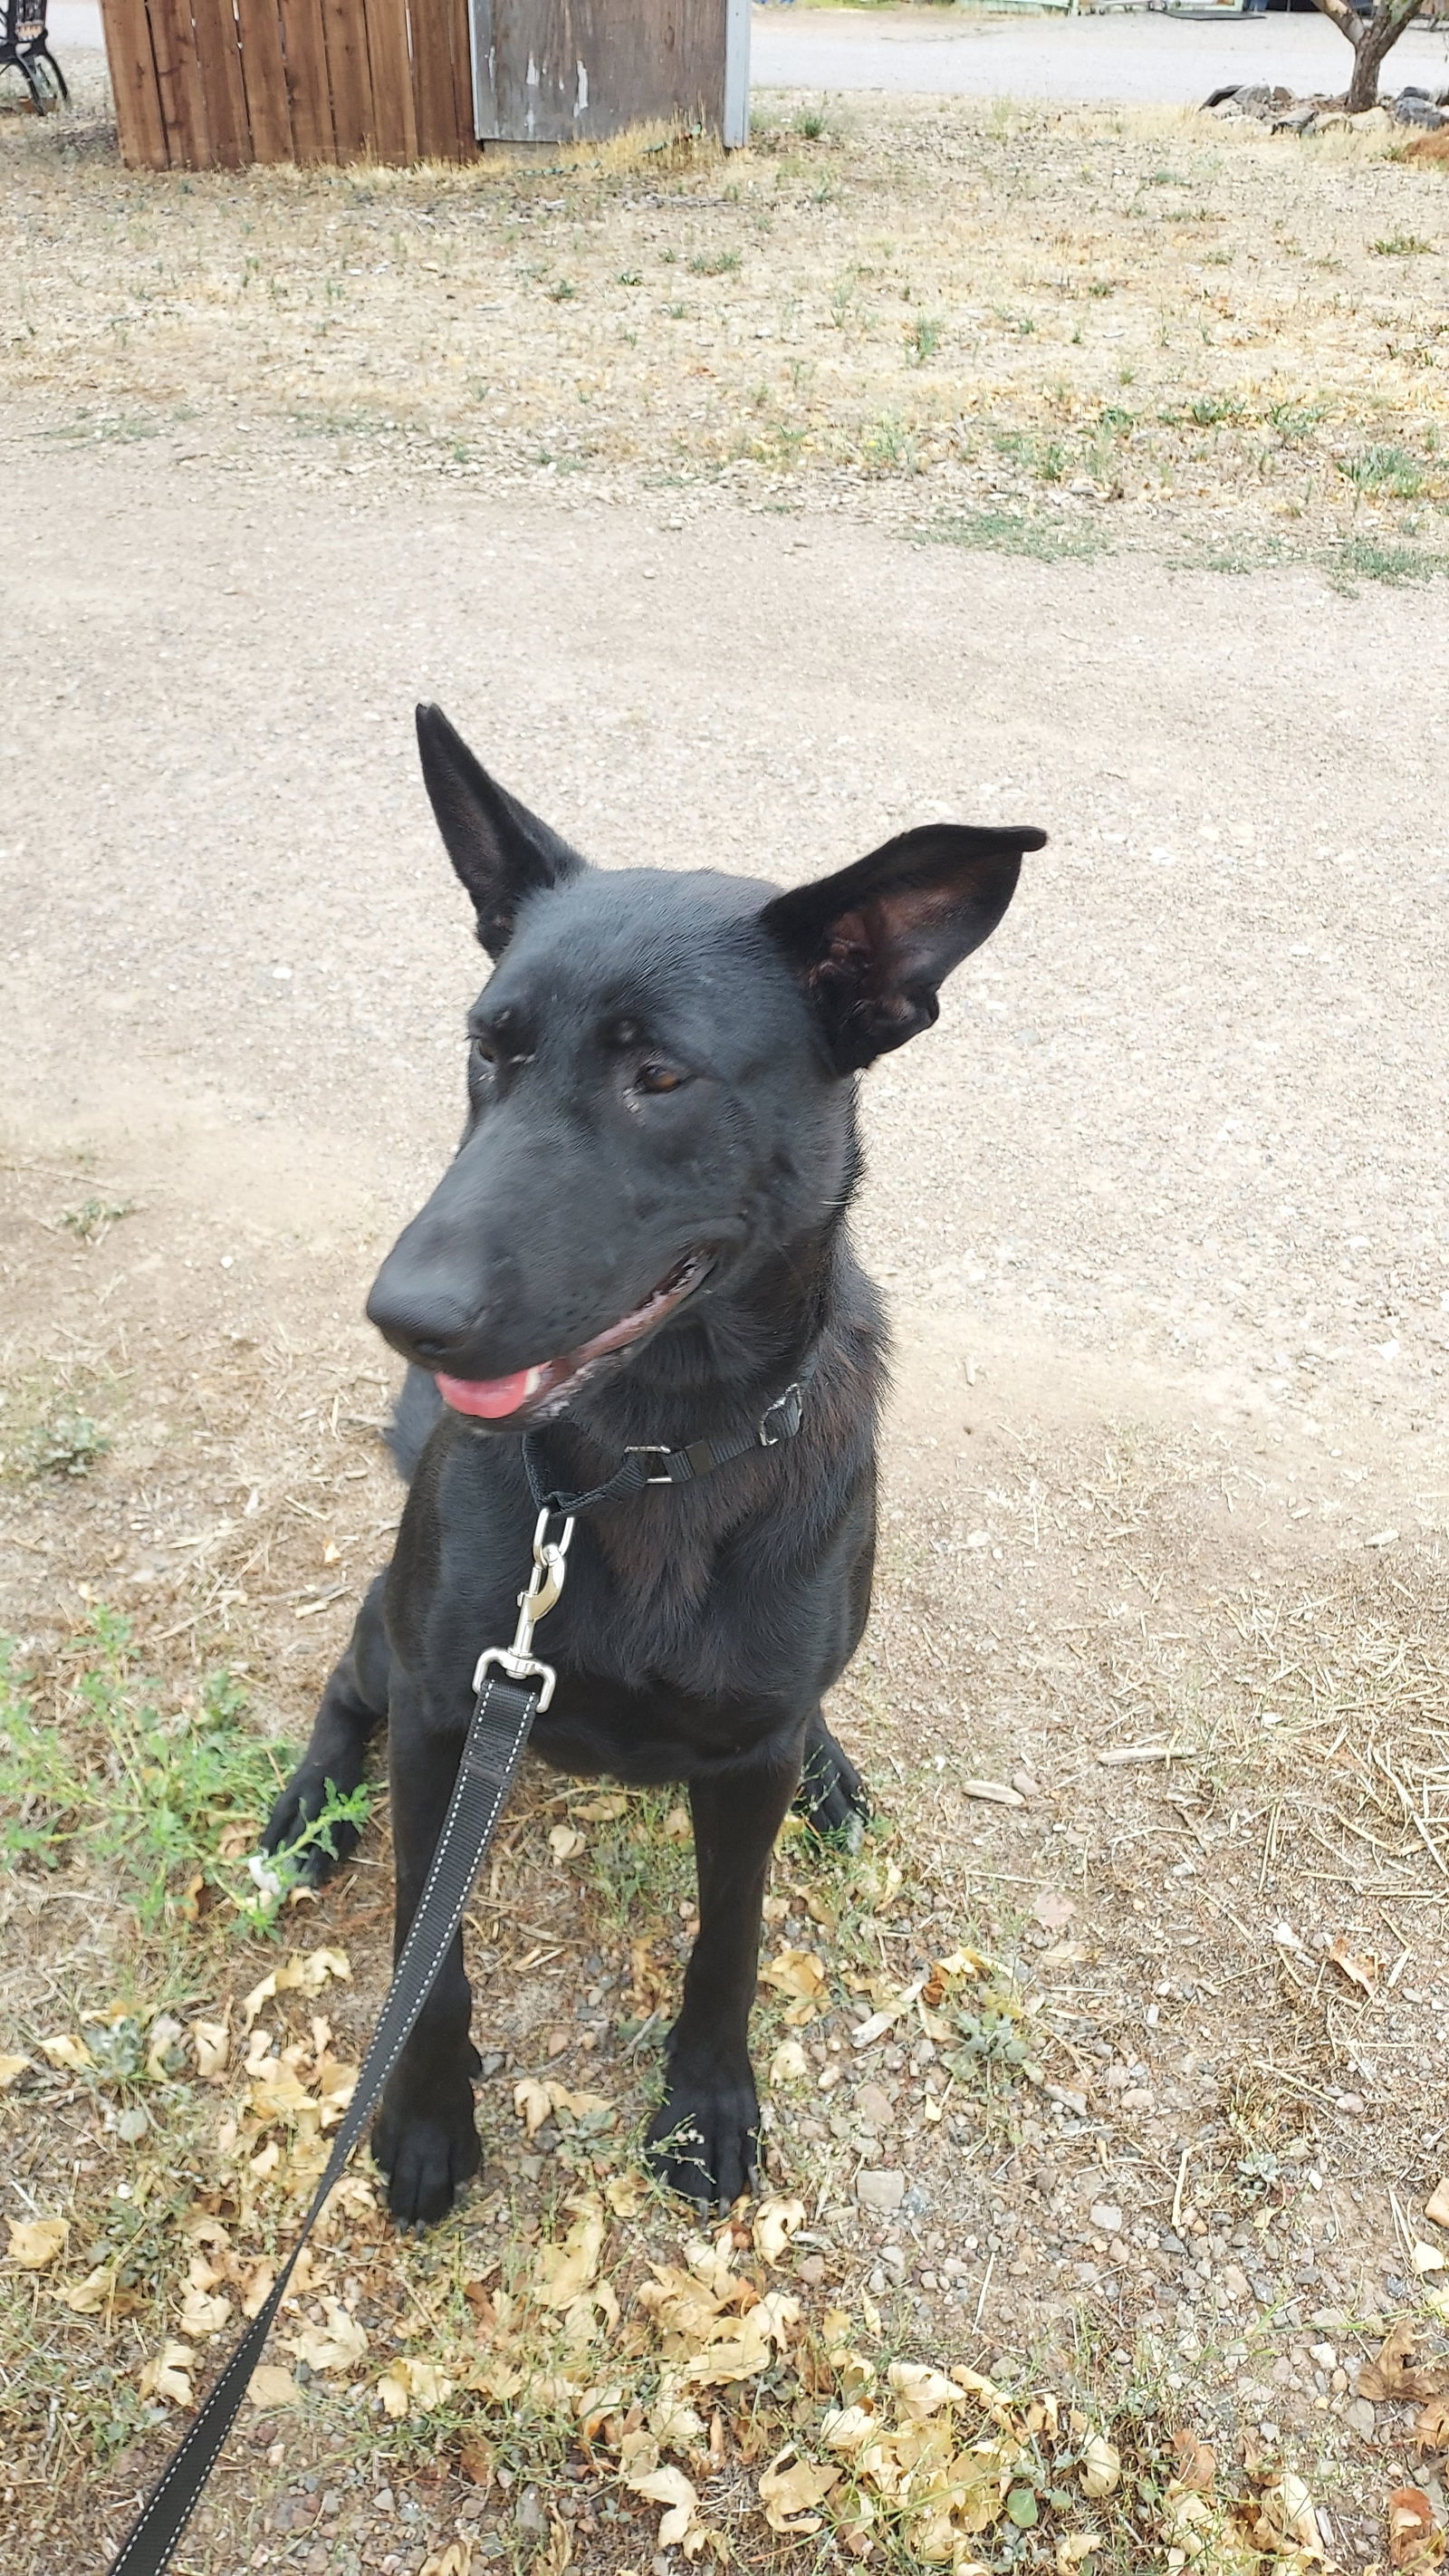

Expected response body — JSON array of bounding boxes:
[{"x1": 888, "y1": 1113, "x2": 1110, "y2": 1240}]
[{"x1": 103, "y1": 0, "x2": 479, "y2": 170}]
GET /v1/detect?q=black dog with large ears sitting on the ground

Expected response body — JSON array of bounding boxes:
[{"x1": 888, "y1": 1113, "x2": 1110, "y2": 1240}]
[{"x1": 268, "y1": 708, "x2": 1045, "y2": 2221}]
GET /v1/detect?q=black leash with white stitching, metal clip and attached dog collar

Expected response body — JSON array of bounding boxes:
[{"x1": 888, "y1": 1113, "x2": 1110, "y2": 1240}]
[{"x1": 108, "y1": 1352, "x2": 819, "y2": 2576}]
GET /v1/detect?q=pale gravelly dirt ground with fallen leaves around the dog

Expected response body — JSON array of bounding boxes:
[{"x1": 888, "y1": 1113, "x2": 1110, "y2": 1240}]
[{"x1": 0, "y1": 45, "x2": 1449, "y2": 2576}]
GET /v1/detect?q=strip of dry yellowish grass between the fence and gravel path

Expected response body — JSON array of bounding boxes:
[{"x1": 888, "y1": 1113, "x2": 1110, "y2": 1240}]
[{"x1": 0, "y1": 63, "x2": 1449, "y2": 574}]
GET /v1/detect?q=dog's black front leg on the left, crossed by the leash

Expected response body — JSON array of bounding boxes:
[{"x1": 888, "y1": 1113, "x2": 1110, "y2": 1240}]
[{"x1": 373, "y1": 1667, "x2": 481, "y2": 2225}]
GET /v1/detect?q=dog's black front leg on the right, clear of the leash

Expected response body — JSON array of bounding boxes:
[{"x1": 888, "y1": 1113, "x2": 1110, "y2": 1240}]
[{"x1": 648, "y1": 1742, "x2": 801, "y2": 2207}]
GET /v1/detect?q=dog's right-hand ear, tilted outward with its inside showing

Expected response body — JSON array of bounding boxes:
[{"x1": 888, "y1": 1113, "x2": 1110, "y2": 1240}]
[{"x1": 759, "y1": 822, "x2": 1048, "y2": 1074}]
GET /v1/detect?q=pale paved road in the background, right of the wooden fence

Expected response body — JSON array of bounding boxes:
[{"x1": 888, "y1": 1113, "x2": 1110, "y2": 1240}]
[{"x1": 752, "y1": 8, "x2": 1449, "y2": 108}]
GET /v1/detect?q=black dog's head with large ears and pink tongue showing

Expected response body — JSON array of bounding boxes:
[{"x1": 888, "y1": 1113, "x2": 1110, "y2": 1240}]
[{"x1": 368, "y1": 706, "x2": 1045, "y2": 1429}]
